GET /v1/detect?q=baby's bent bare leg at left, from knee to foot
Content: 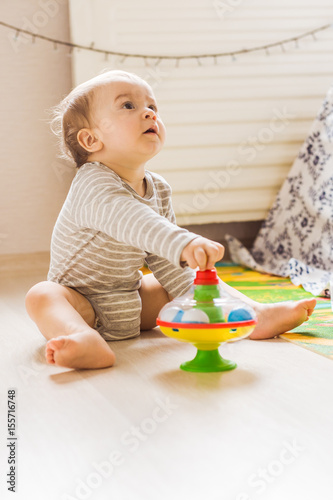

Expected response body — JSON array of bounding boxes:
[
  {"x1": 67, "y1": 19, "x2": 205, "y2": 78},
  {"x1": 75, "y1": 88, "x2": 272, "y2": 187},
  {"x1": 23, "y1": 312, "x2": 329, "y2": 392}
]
[{"x1": 26, "y1": 281, "x2": 115, "y2": 368}]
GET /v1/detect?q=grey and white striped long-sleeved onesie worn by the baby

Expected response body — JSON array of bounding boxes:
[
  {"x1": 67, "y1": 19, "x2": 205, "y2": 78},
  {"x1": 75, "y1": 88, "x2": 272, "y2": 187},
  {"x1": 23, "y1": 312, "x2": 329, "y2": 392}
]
[{"x1": 48, "y1": 162, "x2": 197, "y2": 340}]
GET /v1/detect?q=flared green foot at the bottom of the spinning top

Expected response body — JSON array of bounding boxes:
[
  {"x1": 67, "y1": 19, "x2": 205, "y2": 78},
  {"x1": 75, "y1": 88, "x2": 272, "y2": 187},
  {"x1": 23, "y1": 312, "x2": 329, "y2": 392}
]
[{"x1": 180, "y1": 349, "x2": 237, "y2": 373}]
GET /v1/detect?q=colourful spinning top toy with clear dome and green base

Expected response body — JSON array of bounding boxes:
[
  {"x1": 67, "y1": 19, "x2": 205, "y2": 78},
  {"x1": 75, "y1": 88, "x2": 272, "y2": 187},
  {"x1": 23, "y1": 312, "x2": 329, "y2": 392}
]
[{"x1": 157, "y1": 268, "x2": 257, "y2": 372}]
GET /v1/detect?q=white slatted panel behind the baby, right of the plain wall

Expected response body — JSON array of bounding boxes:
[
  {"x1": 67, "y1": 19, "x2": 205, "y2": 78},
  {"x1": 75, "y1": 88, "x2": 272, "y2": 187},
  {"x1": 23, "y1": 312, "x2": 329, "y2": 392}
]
[{"x1": 70, "y1": 0, "x2": 333, "y2": 224}]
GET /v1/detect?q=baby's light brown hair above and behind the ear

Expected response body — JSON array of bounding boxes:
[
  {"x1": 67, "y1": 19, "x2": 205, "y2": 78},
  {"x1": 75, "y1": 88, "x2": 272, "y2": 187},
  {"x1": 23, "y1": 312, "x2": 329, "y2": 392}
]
[{"x1": 51, "y1": 70, "x2": 147, "y2": 168}]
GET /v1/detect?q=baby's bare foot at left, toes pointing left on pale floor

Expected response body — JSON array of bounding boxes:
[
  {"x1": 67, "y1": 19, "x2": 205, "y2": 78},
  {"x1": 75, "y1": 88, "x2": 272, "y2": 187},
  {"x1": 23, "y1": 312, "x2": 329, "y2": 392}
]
[{"x1": 45, "y1": 330, "x2": 115, "y2": 369}]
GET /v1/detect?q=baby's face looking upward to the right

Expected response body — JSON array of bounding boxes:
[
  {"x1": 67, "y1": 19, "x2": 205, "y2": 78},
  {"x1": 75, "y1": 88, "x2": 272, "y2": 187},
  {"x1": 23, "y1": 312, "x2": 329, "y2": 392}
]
[{"x1": 92, "y1": 79, "x2": 165, "y2": 165}]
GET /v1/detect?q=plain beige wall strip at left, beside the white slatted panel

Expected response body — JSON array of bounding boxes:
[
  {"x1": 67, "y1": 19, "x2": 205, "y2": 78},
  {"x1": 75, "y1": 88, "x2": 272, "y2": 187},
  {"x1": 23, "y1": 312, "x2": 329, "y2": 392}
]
[{"x1": 0, "y1": 0, "x2": 73, "y2": 254}]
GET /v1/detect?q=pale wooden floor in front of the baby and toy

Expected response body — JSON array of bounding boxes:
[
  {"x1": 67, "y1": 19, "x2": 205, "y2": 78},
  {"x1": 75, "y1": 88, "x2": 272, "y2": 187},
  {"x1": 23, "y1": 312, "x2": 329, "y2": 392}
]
[{"x1": 0, "y1": 269, "x2": 333, "y2": 500}]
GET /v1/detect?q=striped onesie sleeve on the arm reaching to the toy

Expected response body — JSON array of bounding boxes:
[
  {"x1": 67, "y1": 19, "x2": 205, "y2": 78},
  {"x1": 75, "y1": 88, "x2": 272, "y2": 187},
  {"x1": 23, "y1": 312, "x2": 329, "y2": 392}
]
[{"x1": 68, "y1": 162, "x2": 197, "y2": 267}]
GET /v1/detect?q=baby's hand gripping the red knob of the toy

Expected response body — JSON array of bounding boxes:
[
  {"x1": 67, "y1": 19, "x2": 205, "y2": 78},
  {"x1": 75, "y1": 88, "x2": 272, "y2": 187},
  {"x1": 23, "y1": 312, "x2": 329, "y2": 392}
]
[{"x1": 180, "y1": 236, "x2": 224, "y2": 271}]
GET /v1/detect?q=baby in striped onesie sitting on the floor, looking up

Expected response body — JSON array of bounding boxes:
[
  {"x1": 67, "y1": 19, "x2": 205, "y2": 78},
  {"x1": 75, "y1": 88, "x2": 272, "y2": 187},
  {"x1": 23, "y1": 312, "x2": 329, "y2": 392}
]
[{"x1": 26, "y1": 71, "x2": 316, "y2": 368}]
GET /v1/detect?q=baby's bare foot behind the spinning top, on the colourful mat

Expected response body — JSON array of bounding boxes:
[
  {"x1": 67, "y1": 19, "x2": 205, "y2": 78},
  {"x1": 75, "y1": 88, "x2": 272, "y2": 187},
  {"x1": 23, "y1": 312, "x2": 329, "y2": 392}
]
[{"x1": 250, "y1": 298, "x2": 317, "y2": 340}]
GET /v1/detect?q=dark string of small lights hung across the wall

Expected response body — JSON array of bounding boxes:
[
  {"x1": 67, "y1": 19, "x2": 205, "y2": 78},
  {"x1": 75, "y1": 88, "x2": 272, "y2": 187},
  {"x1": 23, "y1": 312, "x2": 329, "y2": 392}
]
[{"x1": 0, "y1": 21, "x2": 332, "y2": 67}]
